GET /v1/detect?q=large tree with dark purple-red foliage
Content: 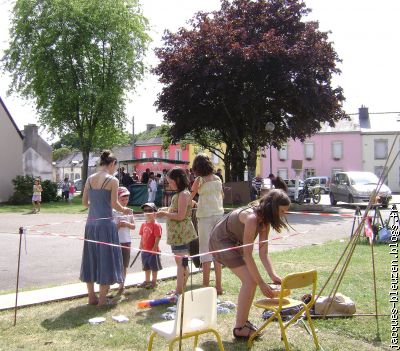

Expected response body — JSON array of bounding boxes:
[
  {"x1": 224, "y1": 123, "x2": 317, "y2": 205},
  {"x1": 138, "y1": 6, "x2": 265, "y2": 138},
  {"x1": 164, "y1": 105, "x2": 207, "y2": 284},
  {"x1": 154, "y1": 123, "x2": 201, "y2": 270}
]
[{"x1": 154, "y1": 0, "x2": 345, "y2": 182}]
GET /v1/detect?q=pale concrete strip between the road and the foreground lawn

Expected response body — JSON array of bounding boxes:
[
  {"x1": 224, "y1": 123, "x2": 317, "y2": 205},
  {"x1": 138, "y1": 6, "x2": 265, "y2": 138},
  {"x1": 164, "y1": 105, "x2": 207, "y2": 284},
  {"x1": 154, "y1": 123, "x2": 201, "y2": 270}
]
[{"x1": 0, "y1": 267, "x2": 199, "y2": 311}]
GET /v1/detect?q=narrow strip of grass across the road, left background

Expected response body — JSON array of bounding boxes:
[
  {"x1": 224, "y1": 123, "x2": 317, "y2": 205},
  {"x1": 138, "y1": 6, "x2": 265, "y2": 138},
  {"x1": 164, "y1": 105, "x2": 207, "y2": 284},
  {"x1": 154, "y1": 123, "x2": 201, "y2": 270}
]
[{"x1": 0, "y1": 196, "x2": 142, "y2": 214}]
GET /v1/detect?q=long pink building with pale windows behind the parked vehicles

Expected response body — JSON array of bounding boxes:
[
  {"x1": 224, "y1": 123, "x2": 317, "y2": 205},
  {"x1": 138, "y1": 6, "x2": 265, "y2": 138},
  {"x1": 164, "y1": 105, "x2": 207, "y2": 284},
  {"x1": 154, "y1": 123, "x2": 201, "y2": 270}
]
[{"x1": 261, "y1": 116, "x2": 363, "y2": 179}]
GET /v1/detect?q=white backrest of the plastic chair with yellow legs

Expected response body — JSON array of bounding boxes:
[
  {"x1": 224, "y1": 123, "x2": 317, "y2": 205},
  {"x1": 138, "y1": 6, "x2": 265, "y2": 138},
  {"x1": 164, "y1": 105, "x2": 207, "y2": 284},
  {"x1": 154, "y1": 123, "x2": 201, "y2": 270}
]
[{"x1": 174, "y1": 287, "x2": 217, "y2": 336}]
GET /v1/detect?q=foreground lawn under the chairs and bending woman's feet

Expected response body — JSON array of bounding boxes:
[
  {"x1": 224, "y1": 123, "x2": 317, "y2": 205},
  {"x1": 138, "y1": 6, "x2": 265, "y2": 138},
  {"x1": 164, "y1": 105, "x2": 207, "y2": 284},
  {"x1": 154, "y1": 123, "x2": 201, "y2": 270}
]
[{"x1": 0, "y1": 242, "x2": 390, "y2": 351}]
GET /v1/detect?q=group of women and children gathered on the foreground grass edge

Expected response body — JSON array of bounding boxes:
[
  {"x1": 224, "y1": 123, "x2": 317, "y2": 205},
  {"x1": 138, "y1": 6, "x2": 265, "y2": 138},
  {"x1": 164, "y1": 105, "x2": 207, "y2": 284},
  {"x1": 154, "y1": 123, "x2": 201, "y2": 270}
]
[{"x1": 80, "y1": 151, "x2": 290, "y2": 339}]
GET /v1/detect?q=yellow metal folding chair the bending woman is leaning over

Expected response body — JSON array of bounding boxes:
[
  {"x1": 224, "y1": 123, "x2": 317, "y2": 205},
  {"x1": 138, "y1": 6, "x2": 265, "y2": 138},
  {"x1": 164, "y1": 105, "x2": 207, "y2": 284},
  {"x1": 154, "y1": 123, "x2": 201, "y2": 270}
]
[{"x1": 247, "y1": 270, "x2": 320, "y2": 351}]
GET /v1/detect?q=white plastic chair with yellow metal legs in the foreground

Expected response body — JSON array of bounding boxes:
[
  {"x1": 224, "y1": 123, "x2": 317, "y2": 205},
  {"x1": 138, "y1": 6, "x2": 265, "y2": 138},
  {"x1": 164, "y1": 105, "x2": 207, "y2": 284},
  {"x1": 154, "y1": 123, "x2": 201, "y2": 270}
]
[{"x1": 148, "y1": 287, "x2": 224, "y2": 351}]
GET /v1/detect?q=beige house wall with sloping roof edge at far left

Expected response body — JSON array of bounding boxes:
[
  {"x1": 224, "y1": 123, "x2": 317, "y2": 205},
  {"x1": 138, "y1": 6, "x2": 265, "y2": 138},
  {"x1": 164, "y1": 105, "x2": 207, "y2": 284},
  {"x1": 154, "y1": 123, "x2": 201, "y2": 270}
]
[{"x1": 0, "y1": 97, "x2": 24, "y2": 202}]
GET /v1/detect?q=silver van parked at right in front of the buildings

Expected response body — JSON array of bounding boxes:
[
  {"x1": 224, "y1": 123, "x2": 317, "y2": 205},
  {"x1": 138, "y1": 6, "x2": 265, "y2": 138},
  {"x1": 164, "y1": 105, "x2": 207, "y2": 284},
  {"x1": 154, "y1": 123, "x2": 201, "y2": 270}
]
[{"x1": 329, "y1": 172, "x2": 392, "y2": 207}]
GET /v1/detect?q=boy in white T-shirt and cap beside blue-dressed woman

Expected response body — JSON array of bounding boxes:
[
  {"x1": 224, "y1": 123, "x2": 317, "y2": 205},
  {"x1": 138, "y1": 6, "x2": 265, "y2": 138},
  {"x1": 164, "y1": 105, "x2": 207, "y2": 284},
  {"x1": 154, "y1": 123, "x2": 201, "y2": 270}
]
[{"x1": 113, "y1": 186, "x2": 135, "y2": 295}]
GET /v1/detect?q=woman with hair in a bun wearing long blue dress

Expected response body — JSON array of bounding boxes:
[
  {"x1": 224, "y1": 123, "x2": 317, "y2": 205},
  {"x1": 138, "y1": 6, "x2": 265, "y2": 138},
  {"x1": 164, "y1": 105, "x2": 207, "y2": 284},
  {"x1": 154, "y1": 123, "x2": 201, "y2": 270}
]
[{"x1": 80, "y1": 150, "x2": 132, "y2": 306}]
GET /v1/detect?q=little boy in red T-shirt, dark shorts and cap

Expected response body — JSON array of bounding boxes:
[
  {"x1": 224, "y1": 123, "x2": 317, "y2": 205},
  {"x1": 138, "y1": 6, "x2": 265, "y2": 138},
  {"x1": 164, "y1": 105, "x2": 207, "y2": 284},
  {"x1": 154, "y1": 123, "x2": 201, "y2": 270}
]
[{"x1": 138, "y1": 202, "x2": 162, "y2": 289}]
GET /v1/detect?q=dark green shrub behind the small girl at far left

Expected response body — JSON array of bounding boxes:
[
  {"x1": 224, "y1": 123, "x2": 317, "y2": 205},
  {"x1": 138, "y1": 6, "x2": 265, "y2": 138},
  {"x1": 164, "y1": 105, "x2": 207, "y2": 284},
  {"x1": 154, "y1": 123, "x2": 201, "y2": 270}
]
[{"x1": 9, "y1": 175, "x2": 59, "y2": 205}]
